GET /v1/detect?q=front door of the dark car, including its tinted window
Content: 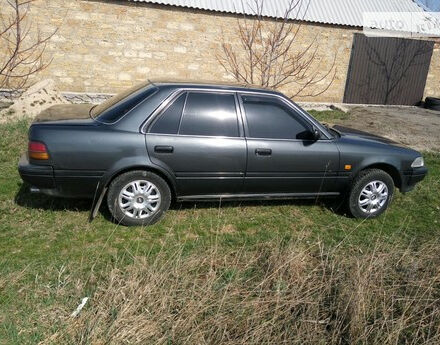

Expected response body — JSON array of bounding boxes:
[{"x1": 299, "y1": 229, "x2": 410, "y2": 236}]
[{"x1": 241, "y1": 94, "x2": 339, "y2": 196}]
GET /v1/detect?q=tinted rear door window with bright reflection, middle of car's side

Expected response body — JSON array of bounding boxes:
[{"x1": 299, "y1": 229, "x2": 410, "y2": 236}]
[{"x1": 179, "y1": 92, "x2": 239, "y2": 137}]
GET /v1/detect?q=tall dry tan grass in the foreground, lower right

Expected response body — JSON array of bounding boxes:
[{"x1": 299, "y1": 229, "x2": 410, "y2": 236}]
[{"x1": 46, "y1": 241, "x2": 440, "y2": 345}]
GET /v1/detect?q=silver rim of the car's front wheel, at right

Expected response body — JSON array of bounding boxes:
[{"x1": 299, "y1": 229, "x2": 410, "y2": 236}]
[{"x1": 358, "y1": 181, "x2": 388, "y2": 214}]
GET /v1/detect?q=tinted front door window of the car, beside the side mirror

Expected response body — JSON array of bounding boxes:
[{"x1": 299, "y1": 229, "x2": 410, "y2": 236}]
[{"x1": 242, "y1": 95, "x2": 309, "y2": 139}]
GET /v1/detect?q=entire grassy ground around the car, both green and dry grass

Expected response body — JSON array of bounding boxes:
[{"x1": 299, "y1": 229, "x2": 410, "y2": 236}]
[{"x1": 0, "y1": 121, "x2": 440, "y2": 345}]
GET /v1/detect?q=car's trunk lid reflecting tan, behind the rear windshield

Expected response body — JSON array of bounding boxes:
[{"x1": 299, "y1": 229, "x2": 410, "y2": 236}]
[{"x1": 34, "y1": 104, "x2": 93, "y2": 124}]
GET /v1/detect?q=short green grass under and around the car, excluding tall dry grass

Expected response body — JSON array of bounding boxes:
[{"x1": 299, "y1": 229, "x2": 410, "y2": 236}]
[{"x1": 0, "y1": 117, "x2": 440, "y2": 344}]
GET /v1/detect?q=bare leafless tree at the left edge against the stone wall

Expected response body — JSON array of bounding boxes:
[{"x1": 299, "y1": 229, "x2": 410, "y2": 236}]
[{"x1": 0, "y1": 0, "x2": 58, "y2": 91}]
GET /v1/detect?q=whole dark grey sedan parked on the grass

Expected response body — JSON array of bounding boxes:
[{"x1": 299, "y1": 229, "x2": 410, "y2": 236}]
[{"x1": 19, "y1": 81, "x2": 427, "y2": 225}]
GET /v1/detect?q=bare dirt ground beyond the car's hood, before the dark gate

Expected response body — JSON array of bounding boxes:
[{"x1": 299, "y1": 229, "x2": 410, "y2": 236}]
[{"x1": 328, "y1": 106, "x2": 440, "y2": 151}]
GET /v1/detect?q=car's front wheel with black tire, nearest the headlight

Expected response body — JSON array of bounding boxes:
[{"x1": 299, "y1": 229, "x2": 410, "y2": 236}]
[{"x1": 348, "y1": 169, "x2": 394, "y2": 219}]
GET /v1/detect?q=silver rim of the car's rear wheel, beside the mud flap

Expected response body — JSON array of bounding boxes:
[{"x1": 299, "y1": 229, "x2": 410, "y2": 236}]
[{"x1": 118, "y1": 180, "x2": 162, "y2": 219}]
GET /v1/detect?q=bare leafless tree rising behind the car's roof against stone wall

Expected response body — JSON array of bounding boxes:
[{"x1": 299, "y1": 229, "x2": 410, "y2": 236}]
[{"x1": 217, "y1": 0, "x2": 336, "y2": 97}]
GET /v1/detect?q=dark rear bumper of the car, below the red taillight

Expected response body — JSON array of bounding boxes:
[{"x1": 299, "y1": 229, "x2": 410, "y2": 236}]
[{"x1": 18, "y1": 154, "x2": 56, "y2": 189}]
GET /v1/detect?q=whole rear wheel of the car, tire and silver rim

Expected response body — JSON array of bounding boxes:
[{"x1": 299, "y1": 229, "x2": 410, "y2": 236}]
[{"x1": 107, "y1": 170, "x2": 171, "y2": 226}]
